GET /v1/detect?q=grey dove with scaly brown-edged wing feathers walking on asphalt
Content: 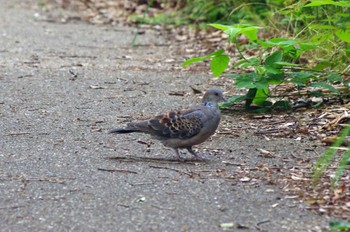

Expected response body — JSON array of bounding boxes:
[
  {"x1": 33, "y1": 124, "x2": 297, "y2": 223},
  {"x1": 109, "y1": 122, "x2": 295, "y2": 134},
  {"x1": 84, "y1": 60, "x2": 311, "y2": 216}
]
[{"x1": 109, "y1": 88, "x2": 226, "y2": 160}]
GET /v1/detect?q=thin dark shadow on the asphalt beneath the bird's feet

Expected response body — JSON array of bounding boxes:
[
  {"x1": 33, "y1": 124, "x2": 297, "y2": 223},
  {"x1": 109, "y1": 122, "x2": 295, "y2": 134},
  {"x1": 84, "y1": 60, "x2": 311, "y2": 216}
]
[{"x1": 106, "y1": 156, "x2": 210, "y2": 165}]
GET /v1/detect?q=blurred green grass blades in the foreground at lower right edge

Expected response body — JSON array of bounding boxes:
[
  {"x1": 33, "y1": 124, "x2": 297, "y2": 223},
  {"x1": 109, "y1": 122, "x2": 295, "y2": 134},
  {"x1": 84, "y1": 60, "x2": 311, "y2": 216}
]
[{"x1": 312, "y1": 123, "x2": 350, "y2": 187}]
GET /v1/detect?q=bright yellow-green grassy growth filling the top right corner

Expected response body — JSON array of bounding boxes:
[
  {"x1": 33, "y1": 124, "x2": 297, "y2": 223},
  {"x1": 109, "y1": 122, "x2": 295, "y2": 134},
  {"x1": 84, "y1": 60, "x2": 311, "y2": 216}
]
[{"x1": 270, "y1": 0, "x2": 350, "y2": 73}]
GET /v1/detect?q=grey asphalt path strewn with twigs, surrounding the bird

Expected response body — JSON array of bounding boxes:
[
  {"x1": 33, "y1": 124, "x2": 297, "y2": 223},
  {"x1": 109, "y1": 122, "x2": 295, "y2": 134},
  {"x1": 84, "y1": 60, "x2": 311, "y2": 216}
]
[{"x1": 0, "y1": 0, "x2": 340, "y2": 231}]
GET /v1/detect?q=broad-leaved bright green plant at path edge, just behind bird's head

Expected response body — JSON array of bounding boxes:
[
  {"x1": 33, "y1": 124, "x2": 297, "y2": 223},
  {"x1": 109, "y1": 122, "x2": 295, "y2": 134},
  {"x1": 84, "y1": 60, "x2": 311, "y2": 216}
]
[{"x1": 183, "y1": 24, "x2": 337, "y2": 109}]
